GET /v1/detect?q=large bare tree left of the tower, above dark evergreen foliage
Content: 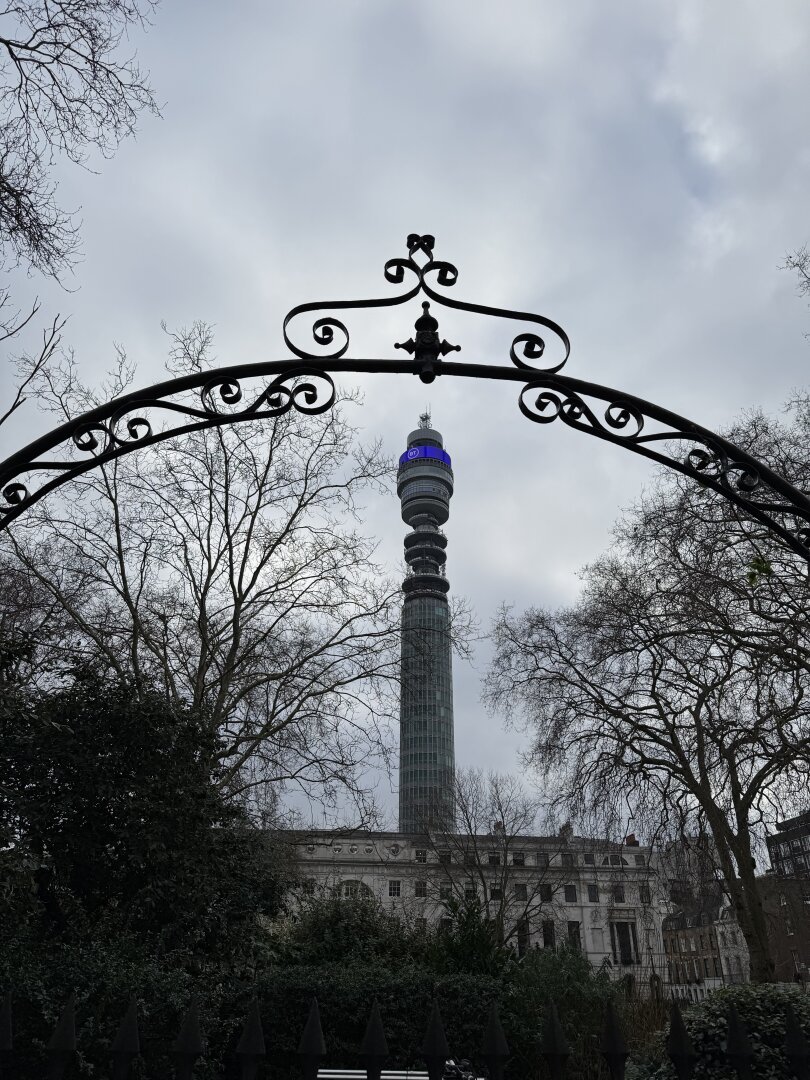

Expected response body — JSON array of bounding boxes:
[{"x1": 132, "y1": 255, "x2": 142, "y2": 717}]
[{"x1": 4, "y1": 325, "x2": 400, "y2": 818}]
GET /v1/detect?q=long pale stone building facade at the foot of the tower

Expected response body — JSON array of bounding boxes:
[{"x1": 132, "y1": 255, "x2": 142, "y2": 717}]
[{"x1": 298, "y1": 827, "x2": 667, "y2": 995}]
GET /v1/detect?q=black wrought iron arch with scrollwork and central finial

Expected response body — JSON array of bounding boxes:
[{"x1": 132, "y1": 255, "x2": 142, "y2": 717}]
[{"x1": 0, "y1": 233, "x2": 810, "y2": 561}]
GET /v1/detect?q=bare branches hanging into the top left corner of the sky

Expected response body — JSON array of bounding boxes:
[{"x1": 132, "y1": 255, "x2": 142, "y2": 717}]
[{"x1": 0, "y1": 0, "x2": 157, "y2": 275}]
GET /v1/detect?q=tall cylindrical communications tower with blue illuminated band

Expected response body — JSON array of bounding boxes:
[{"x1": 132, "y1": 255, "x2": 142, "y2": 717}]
[{"x1": 396, "y1": 413, "x2": 456, "y2": 833}]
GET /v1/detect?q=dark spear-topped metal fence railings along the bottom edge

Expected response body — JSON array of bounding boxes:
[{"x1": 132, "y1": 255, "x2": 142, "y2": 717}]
[{"x1": 0, "y1": 995, "x2": 810, "y2": 1080}]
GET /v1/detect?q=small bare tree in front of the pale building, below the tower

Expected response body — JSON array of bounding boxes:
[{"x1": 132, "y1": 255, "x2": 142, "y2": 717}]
[{"x1": 426, "y1": 769, "x2": 566, "y2": 949}]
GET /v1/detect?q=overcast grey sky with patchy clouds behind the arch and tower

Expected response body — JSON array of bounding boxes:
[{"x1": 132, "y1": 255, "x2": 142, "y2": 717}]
[{"x1": 0, "y1": 0, "x2": 810, "y2": 825}]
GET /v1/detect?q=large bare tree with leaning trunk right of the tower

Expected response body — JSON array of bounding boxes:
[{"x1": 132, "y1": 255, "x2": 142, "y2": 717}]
[{"x1": 487, "y1": 403, "x2": 810, "y2": 981}]
